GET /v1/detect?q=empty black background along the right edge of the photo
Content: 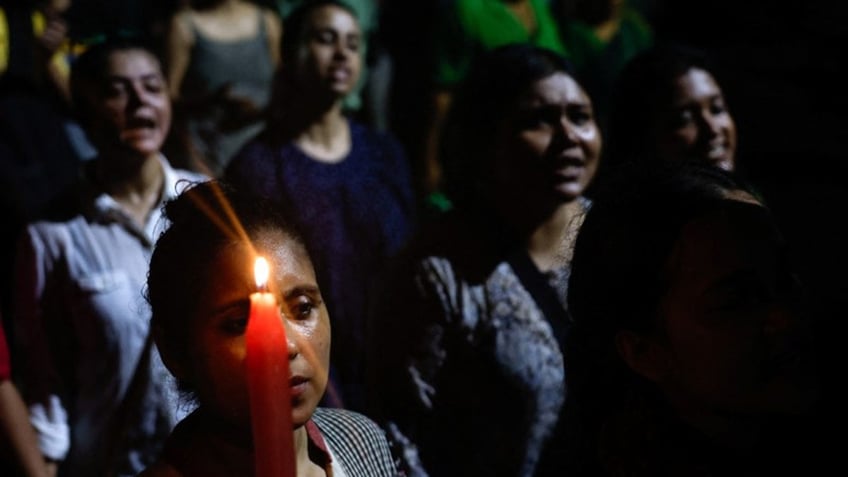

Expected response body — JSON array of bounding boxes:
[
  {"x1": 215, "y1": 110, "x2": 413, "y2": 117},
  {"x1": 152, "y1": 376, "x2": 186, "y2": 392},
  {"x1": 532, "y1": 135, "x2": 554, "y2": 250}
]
[{"x1": 648, "y1": 0, "x2": 848, "y2": 418}]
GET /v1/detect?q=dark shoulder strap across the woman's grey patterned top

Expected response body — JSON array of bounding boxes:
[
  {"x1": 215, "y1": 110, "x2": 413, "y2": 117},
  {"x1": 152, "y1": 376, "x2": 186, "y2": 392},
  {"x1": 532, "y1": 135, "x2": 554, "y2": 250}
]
[{"x1": 507, "y1": 248, "x2": 571, "y2": 351}]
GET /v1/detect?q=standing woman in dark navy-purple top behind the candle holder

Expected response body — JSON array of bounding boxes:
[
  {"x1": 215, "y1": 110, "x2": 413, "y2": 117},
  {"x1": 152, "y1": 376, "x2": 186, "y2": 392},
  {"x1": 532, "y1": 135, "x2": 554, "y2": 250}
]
[{"x1": 225, "y1": 1, "x2": 414, "y2": 409}]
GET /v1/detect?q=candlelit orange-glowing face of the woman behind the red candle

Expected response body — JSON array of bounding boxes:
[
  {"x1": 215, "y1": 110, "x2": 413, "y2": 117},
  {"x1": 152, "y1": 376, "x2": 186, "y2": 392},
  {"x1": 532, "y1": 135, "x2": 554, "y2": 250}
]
[{"x1": 180, "y1": 230, "x2": 330, "y2": 429}]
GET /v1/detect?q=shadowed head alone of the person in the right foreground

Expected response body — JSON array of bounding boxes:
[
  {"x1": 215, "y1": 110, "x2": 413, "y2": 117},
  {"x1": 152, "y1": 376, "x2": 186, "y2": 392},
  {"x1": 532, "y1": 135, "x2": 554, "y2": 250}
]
[{"x1": 565, "y1": 162, "x2": 814, "y2": 462}]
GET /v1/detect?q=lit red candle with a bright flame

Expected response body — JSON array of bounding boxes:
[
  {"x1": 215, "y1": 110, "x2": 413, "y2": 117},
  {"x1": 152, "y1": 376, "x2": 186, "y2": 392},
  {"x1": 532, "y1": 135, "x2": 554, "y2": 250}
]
[{"x1": 245, "y1": 257, "x2": 296, "y2": 477}]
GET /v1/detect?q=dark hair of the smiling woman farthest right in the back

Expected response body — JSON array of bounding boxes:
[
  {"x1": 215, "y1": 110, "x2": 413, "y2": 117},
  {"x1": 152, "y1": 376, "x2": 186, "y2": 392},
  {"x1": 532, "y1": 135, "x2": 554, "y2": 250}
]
[{"x1": 604, "y1": 43, "x2": 718, "y2": 167}]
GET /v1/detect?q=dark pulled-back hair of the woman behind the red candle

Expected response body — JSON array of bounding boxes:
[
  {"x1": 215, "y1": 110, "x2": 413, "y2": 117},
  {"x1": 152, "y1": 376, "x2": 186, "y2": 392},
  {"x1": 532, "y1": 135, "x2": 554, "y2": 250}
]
[{"x1": 146, "y1": 180, "x2": 309, "y2": 391}]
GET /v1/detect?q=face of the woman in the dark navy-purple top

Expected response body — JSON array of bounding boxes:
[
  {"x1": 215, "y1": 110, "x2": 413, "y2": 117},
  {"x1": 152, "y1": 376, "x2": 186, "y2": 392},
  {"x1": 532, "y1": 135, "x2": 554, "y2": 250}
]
[{"x1": 296, "y1": 5, "x2": 362, "y2": 97}]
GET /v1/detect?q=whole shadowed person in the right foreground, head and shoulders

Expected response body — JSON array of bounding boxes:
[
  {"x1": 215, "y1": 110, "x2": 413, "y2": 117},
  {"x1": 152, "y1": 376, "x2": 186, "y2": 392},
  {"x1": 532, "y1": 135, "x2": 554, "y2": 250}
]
[{"x1": 540, "y1": 161, "x2": 826, "y2": 476}]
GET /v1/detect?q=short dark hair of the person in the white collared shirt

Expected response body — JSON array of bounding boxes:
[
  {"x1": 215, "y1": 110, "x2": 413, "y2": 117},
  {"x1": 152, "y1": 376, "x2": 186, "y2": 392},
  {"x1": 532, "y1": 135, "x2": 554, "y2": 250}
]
[{"x1": 70, "y1": 34, "x2": 165, "y2": 127}]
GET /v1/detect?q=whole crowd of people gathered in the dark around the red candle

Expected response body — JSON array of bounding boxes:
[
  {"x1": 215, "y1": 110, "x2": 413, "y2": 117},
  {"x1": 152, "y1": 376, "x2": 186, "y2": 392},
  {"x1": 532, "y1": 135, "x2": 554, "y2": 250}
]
[{"x1": 0, "y1": 0, "x2": 848, "y2": 477}]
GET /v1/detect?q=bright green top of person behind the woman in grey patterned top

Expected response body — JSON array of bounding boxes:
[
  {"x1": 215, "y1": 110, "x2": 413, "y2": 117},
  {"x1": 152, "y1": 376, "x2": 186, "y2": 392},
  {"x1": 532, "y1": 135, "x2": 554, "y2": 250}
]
[{"x1": 434, "y1": 0, "x2": 567, "y2": 87}]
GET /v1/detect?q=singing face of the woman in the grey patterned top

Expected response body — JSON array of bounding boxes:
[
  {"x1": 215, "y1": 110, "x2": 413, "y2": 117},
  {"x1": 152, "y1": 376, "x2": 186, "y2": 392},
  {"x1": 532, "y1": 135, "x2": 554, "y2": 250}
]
[{"x1": 494, "y1": 73, "x2": 601, "y2": 202}]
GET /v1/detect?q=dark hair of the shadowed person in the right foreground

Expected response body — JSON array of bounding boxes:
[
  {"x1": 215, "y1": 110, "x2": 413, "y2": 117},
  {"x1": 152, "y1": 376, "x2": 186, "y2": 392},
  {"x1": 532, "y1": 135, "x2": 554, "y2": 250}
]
[{"x1": 569, "y1": 161, "x2": 756, "y2": 330}]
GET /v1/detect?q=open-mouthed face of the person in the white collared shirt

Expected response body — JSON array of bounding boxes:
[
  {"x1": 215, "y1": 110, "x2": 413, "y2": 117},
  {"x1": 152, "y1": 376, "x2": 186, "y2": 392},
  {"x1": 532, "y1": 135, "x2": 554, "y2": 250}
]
[{"x1": 87, "y1": 50, "x2": 171, "y2": 157}]
